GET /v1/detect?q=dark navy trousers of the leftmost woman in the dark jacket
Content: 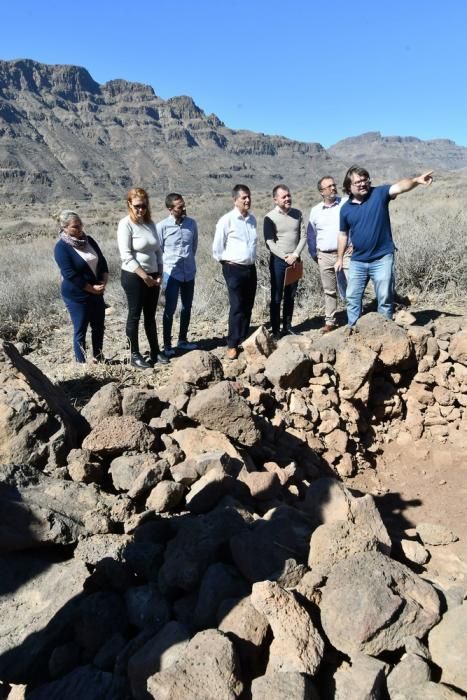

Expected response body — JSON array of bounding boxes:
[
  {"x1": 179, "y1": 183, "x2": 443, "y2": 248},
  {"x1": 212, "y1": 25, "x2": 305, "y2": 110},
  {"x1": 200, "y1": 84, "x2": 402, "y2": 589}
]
[{"x1": 64, "y1": 294, "x2": 105, "y2": 362}]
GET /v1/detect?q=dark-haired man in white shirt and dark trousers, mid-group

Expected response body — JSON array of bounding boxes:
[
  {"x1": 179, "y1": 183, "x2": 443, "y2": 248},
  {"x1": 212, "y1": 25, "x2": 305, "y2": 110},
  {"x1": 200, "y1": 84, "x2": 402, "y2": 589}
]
[{"x1": 212, "y1": 185, "x2": 257, "y2": 360}]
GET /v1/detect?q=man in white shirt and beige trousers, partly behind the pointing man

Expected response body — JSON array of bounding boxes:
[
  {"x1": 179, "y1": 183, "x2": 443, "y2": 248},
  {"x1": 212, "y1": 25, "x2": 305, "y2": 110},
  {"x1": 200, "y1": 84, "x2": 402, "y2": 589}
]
[{"x1": 306, "y1": 175, "x2": 350, "y2": 333}]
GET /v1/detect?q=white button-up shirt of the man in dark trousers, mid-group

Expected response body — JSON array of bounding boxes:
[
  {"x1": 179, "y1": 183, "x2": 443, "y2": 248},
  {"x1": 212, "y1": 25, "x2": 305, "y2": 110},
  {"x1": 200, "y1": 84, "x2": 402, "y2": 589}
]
[{"x1": 212, "y1": 207, "x2": 257, "y2": 265}]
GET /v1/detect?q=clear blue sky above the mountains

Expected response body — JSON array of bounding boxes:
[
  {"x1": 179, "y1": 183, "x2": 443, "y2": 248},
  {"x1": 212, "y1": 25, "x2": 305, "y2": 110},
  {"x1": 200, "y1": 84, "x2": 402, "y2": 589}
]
[{"x1": 0, "y1": 0, "x2": 467, "y2": 147}]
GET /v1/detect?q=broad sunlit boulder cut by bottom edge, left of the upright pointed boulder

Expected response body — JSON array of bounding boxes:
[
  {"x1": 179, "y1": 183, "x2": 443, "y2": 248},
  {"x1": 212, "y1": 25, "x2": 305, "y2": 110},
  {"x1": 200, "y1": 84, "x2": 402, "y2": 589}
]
[{"x1": 148, "y1": 630, "x2": 243, "y2": 700}]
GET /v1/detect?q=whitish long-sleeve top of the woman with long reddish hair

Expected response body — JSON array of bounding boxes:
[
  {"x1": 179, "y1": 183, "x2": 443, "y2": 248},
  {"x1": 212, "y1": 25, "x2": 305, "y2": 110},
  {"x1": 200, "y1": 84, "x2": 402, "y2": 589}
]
[{"x1": 117, "y1": 216, "x2": 163, "y2": 274}]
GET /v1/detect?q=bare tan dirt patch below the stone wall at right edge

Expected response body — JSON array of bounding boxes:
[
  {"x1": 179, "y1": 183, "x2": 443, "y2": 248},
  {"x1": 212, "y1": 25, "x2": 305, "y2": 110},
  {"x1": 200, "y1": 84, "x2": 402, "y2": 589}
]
[{"x1": 348, "y1": 432, "x2": 467, "y2": 588}]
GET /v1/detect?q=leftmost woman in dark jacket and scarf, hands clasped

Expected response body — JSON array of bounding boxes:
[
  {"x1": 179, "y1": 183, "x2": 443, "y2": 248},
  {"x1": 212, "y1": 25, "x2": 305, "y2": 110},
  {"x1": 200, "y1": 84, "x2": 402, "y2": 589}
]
[{"x1": 54, "y1": 209, "x2": 109, "y2": 362}]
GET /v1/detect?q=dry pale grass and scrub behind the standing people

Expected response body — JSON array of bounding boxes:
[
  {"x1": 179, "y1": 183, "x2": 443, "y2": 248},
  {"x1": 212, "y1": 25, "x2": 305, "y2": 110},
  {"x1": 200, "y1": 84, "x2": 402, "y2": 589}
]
[{"x1": 0, "y1": 176, "x2": 467, "y2": 344}]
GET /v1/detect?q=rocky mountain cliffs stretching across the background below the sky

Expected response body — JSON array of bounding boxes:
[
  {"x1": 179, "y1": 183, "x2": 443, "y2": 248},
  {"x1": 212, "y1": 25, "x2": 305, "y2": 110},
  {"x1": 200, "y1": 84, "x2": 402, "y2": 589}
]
[{"x1": 0, "y1": 59, "x2": 467, "y2": 202}]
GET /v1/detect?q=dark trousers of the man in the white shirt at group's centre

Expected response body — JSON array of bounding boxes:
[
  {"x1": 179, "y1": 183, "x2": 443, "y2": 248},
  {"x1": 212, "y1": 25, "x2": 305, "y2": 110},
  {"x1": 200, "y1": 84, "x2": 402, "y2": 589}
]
[{"x1": 222, "y1": 263, "x2": 256, "y2": 348}]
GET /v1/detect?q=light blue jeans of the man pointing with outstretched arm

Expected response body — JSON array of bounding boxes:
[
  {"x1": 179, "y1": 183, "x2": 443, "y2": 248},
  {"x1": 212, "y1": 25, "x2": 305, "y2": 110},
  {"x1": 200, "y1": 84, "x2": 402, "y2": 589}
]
[{"x1": 346, "y1": 253, "x2": 394, "y2": 326}]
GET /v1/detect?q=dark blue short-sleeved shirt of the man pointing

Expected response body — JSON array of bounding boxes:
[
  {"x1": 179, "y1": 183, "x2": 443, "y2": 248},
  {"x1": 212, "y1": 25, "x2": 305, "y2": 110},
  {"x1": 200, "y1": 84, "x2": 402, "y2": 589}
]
[{"x1": 339, "y1": 185, "x2": 394, "y2": 262}]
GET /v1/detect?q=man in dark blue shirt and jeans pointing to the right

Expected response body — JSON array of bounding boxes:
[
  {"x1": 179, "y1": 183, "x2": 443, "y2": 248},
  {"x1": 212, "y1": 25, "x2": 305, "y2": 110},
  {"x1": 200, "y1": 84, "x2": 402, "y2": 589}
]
[{"x1": 335, "y1": 165, "x2": 433, "y2": 327}]
